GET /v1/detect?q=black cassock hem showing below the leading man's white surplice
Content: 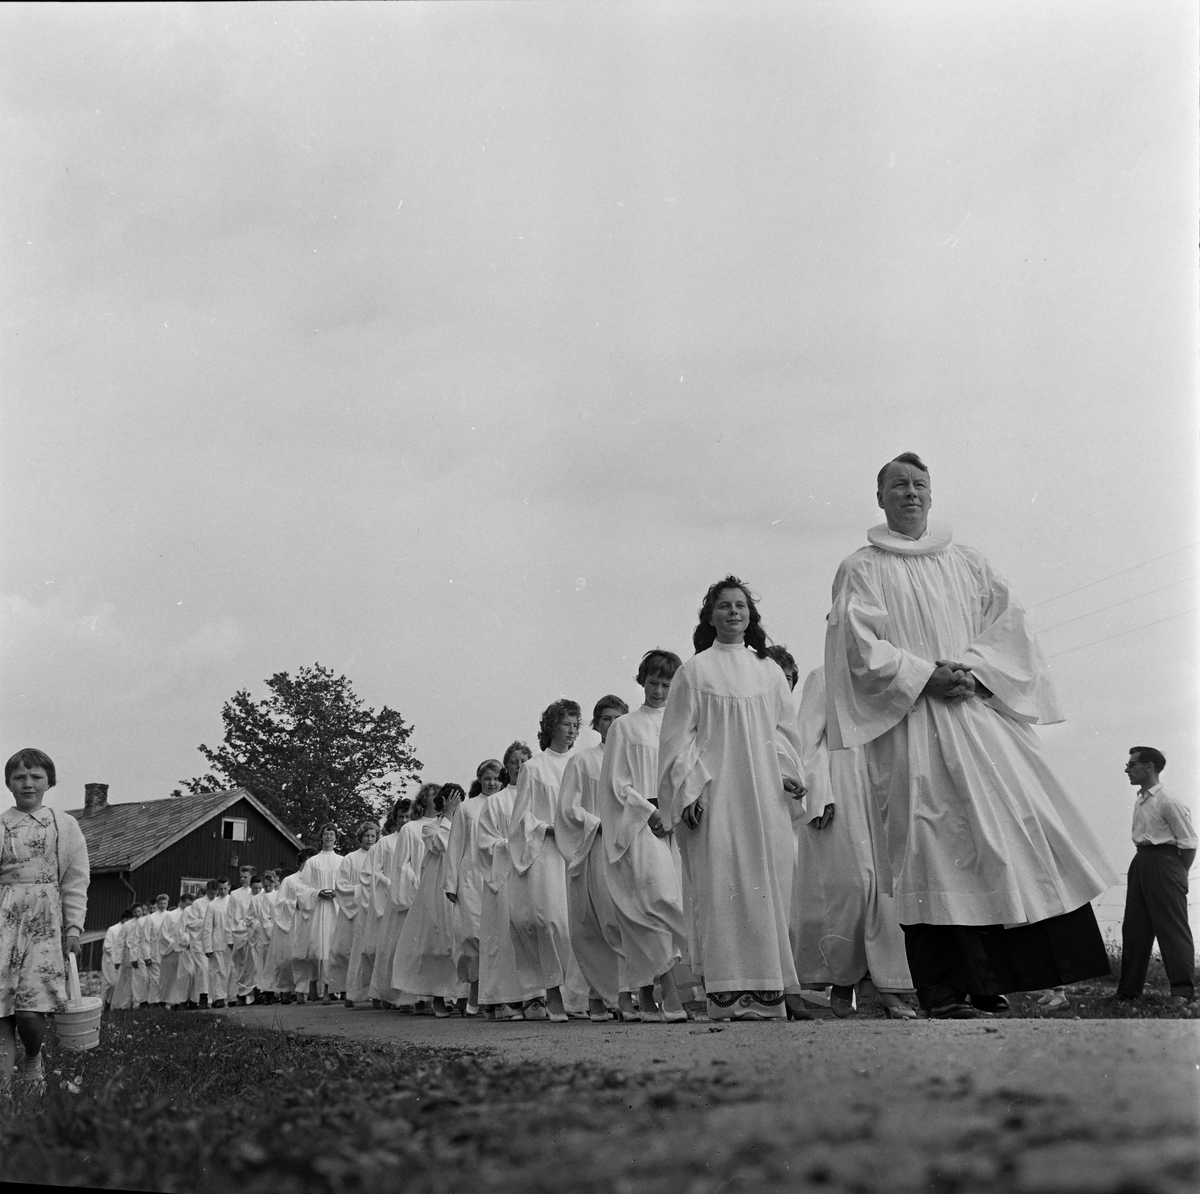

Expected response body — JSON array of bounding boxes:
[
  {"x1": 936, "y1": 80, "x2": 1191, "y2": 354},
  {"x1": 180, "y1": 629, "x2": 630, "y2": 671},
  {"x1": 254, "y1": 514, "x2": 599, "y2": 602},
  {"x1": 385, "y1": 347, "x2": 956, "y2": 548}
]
[{"x1": 901, "y1": 904, "x2": 1111, "y2": 1010}]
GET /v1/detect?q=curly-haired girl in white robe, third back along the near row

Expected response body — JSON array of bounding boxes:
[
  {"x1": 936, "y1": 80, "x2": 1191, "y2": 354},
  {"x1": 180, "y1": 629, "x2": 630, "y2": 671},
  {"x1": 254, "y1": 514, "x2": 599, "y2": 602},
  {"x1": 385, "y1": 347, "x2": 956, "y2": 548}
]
[{"x1": 509, "y1": 700, "x2": 580, "y2": 1024}]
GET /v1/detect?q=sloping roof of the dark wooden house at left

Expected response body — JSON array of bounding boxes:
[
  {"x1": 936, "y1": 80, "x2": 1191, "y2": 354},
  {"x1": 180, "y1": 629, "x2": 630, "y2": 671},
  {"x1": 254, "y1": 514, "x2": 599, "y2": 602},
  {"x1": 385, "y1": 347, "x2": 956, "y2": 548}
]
[{"x1": 67, "y1": 787, "x2": 304, "y2": 871}]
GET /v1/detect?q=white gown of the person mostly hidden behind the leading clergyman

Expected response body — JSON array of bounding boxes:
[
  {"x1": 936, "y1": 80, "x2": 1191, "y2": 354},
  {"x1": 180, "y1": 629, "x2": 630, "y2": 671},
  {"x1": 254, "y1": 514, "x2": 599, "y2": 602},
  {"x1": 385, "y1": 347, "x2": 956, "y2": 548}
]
[{"x1": 792, "y1": 667, "x2": 912, "y2": 991}]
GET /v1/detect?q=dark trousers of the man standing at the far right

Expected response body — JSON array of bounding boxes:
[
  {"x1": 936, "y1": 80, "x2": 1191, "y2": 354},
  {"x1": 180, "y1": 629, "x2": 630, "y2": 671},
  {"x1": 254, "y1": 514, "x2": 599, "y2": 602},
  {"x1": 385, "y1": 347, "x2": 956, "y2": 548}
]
[{"x1": 1117, "y1": 846, "x2": 1195, "y2": 998}]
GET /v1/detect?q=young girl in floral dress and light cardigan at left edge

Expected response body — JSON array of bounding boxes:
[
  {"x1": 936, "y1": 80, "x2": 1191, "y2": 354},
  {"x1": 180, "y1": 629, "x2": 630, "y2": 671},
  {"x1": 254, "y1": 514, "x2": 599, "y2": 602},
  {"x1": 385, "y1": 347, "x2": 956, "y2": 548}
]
[{"x1": 0, "y1": 748, "x2": 89, "y2": 1094}]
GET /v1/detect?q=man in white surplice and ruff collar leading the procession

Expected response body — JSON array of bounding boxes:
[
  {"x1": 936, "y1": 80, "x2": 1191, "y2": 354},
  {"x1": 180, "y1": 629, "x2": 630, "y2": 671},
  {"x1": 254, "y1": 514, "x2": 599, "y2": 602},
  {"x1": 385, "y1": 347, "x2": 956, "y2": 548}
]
[{"x1": 826, "y1": 452, "x2": 1114, "y2": 1019}]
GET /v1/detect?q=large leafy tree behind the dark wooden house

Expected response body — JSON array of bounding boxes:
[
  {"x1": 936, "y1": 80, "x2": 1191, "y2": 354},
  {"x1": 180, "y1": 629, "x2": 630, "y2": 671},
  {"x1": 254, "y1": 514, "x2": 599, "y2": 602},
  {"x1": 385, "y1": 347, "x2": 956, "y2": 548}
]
[{"x1": 173, "y1": 664, "x2": 421, "y2": 845}]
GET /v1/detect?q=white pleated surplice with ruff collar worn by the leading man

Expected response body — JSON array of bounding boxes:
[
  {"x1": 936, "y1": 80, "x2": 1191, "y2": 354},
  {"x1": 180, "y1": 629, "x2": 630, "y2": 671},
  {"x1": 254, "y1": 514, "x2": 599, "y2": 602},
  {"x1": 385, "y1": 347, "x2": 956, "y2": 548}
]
[{"x1": 826, "y1": 523, "x2": 1116, "y2": 926}]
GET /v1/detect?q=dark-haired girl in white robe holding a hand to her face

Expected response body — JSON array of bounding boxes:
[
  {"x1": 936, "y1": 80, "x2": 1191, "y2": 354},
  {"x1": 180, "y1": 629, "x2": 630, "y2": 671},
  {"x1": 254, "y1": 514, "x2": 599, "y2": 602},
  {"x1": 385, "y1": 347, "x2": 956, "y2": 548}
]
[{"x1": 391, "y1": 784, "x2": 469, "y2": 1019}]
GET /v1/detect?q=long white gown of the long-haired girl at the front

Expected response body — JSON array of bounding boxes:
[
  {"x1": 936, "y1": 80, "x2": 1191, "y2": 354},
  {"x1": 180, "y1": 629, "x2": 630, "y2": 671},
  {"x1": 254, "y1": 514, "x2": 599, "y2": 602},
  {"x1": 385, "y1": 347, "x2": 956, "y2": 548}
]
[{"x1": 657, "y1": 642, "x2": 800, "y2": 994}]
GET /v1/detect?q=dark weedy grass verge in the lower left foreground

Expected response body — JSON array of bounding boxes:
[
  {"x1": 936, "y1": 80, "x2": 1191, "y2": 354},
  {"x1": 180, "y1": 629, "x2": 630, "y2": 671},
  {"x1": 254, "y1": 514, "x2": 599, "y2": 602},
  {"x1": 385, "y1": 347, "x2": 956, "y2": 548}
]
[{"x1": 0, "y1": 1009, "x2": 761, "y2": 1194}]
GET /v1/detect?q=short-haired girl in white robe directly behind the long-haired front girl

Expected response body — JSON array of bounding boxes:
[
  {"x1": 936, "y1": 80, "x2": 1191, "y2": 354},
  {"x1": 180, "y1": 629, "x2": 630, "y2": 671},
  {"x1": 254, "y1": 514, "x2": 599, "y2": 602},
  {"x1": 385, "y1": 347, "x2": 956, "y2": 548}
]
[{"x1": 599, "y1": 650, "x2": 688, "y2": 1022}]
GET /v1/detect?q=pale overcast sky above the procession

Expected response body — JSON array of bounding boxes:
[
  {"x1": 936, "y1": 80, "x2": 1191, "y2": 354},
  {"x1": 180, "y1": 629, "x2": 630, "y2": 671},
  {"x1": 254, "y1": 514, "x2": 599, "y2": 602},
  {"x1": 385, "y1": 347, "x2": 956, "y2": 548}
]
[{"x1": 0, "y1": 0, "x2": 1200, "y2": 907}]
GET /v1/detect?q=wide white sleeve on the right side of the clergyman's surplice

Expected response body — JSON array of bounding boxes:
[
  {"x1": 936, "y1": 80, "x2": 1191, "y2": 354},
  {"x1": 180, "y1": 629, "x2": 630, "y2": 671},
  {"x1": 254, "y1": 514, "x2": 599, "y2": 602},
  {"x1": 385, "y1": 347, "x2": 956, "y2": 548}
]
[{"x1": 958, "y1": 556, "x2": 1066, "y2": 726}]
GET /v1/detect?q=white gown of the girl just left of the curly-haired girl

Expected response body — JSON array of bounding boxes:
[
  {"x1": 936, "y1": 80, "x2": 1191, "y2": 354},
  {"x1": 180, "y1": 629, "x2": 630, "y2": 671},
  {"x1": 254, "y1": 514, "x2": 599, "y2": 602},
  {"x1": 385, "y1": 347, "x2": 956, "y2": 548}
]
[{"x1": 479, "y1": 787, "x2": 546, "y2": 1004}]
